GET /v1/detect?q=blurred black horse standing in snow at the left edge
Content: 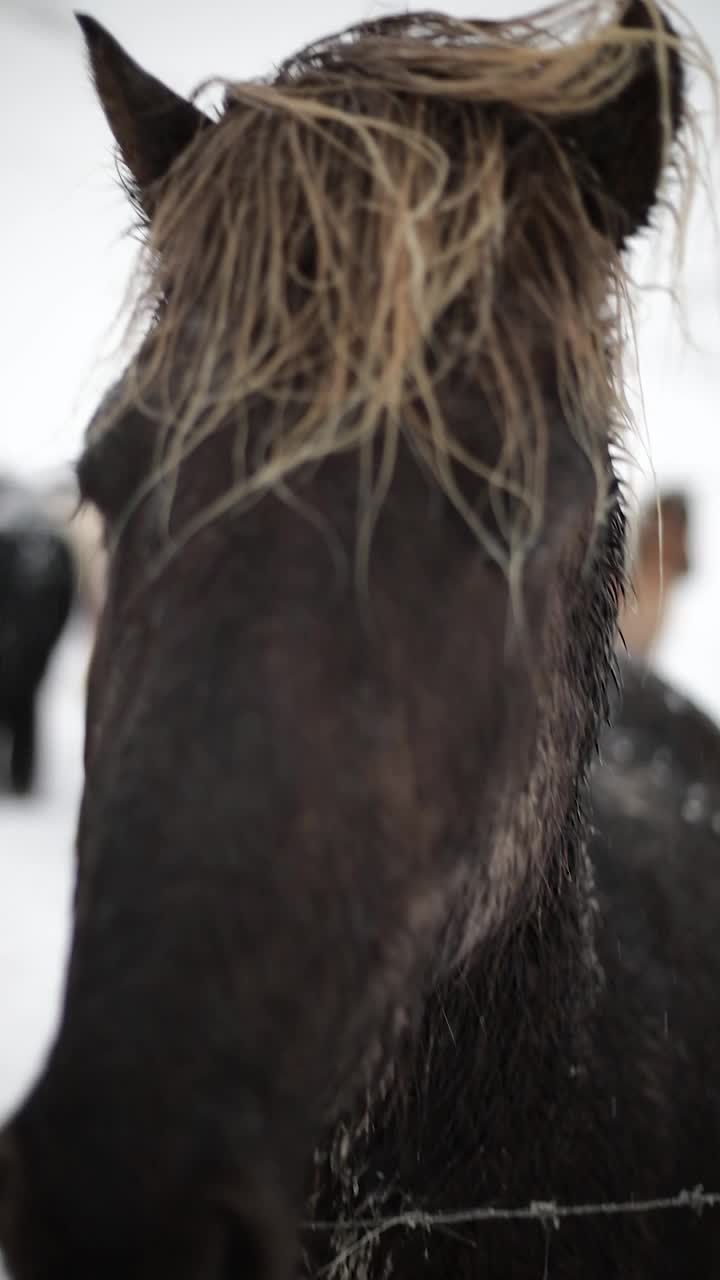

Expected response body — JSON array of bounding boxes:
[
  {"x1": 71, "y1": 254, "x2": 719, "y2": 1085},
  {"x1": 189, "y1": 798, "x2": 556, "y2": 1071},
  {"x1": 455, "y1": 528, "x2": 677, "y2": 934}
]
[{"x1": 0, "y1": 474, "x2": 74, "y2": 795}]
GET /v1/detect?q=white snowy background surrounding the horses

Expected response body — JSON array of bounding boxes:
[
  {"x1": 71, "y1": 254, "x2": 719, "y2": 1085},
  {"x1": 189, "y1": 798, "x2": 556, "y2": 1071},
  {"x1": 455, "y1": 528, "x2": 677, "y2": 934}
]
[{"x1": 0, "y1": 0, "x2": 720, "y2": 1239}]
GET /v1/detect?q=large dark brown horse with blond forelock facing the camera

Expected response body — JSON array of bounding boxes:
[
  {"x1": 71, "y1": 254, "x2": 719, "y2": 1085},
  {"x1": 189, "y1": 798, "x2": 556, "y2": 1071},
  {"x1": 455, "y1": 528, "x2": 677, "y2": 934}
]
[{"x1": 0, "y1": 0, "x2": 720, "y2": 1280}]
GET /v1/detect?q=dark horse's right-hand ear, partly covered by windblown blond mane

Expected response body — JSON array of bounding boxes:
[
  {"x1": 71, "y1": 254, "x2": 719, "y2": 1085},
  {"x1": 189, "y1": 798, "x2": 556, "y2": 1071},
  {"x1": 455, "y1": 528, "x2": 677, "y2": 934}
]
[{"x1": 557, "y1": 0, "x2": 684, "y2": 248}]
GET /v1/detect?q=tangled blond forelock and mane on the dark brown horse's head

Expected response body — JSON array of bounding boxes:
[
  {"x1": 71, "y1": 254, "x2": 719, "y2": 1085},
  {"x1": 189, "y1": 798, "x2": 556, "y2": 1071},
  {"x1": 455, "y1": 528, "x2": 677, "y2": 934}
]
[{"x1": 107, "y1": 0, "x2": 707, "y2": 570}]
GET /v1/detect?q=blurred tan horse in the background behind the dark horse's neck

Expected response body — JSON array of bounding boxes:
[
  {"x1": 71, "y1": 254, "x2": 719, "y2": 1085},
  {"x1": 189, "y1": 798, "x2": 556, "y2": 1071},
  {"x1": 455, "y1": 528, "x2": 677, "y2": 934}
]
[{"x1": 620, "y1": 490, "x2": 691, "y2": 658}]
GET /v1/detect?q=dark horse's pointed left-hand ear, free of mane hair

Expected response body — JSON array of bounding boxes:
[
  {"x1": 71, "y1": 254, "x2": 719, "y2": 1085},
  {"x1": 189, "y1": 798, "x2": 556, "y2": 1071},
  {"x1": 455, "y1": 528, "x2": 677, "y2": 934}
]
[{"x1": 76, "y1": 13, "x2": 211, "y2": 215}]
